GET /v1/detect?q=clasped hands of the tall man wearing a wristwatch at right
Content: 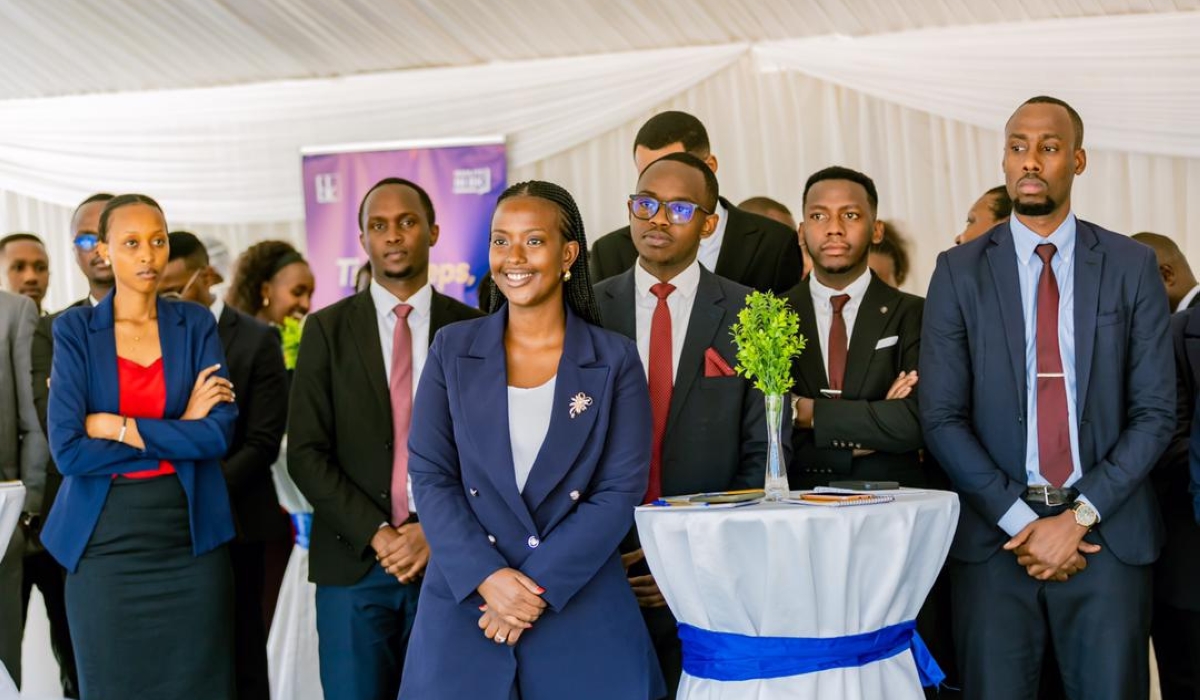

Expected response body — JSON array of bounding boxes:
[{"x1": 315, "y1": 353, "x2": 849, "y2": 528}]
[{"x1": 1004, "y1": 510, "x2": 1100, "y2": 582}]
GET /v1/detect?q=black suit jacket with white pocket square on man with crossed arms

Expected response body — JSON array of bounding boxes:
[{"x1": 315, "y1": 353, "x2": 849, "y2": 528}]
[{"x1": 787, "y1": 273, "x2": 929, "y2": 489}]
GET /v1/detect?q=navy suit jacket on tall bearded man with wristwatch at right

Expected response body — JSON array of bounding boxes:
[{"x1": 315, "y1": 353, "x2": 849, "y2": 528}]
[{"x1": 917, "y1": 220, "x2": 1175, "y2": 564}]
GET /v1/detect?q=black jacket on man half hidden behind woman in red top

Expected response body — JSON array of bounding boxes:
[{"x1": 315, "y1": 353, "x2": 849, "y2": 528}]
[{"x1": 217, "y1": 306, "x2": 288, "y2": 542}]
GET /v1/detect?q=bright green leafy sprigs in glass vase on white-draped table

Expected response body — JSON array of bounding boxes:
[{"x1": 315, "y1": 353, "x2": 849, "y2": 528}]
[{"x1": 730, "y1": 292, "x2": 804, "y2": 396}]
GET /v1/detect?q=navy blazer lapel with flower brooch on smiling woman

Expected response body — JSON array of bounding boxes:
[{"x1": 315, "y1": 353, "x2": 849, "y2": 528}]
[{"x1": 523, "y1": 309, "x2": 610, "y2": 513}]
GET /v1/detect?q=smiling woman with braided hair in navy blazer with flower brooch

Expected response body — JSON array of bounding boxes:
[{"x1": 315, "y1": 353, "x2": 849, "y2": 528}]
[{"x1": 400, "y1": 181, "x2": 666, "y2": 700}]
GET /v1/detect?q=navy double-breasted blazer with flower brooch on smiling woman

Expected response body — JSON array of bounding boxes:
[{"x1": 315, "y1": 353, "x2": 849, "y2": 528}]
[{"x1": 400, "y1": 307, "x2": 665, "y2": 700}]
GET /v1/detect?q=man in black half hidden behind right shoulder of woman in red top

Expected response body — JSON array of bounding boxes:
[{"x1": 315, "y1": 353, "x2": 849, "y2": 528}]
[{"x1": 158, "y1": 231, "x2": 288, "y2": 700}]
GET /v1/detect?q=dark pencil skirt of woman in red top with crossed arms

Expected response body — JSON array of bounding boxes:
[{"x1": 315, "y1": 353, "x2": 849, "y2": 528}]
[{"x1": 66, "y1": 475, "x2": 235, "y2": 700}]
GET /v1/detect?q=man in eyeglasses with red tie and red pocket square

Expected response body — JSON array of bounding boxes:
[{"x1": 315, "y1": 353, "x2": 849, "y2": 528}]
[{"x1": 596, "y1": 152, "x2": 794, "y2": 698}]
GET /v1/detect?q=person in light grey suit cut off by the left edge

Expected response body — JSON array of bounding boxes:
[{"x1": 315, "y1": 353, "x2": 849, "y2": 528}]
[{"x1": 0, "y1": 292, "x2": 49, "y2": 686}]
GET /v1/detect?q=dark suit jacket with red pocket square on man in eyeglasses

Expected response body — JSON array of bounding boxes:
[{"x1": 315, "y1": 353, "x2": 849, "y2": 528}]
[{"x1": 596, "y1": 268, "x2": 791, "y2": 496}]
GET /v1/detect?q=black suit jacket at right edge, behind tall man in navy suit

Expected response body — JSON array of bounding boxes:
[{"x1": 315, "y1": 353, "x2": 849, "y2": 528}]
[{"x1": 1150, "y1": 309, "x2": 1200, "y2": 611}]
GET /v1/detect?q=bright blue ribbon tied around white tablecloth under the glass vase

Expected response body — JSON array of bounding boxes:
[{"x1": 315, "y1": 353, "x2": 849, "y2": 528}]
[{"x1": 679, "y1": 620, "x2": 946, "y2": 688}]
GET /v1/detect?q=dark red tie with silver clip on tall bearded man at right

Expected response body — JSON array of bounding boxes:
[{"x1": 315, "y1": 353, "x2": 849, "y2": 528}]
[{"x1": 1034, "y1": 243, "x2": 1074, "y2": 489}]
